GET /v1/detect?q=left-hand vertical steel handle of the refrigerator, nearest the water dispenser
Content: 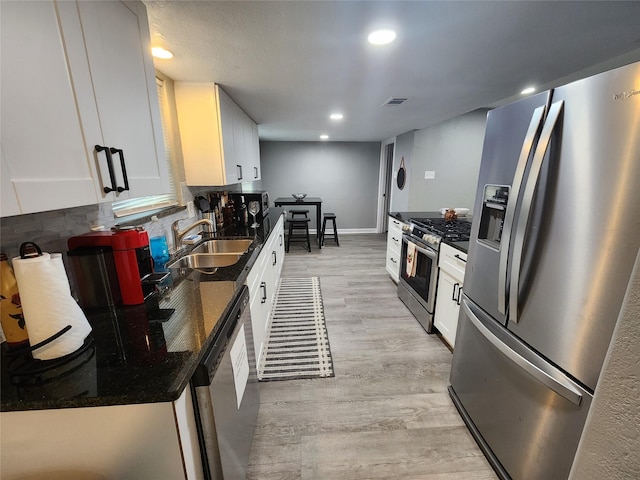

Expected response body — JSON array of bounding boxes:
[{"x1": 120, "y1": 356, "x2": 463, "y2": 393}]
[{"x1": 498, "y1": 106, "x2": 545, "y2": 315}]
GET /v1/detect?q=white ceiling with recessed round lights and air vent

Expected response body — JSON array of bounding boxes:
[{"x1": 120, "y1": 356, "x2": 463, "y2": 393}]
[{"x1": 145, "y1": 0, "x2": 640, "y2": 141}]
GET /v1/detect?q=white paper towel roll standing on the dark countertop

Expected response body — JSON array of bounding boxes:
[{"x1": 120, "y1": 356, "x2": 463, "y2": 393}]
[{"x1": 12, "y1": 253, "x2": 91, "y2": 360}]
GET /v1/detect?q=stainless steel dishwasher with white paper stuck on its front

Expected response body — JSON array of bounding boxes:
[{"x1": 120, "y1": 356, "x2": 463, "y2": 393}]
[{"x1": 192, "y1": 286, "x2": 260, "y2": 480}]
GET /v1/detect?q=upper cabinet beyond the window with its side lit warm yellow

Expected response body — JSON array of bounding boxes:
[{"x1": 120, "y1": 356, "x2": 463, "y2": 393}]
[{"x1": 175, "y1": 82, "x2": 260, "y2": 186}]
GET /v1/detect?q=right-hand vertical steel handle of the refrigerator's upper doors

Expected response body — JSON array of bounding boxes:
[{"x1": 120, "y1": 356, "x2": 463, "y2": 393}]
[{"x1": 509, "y1": 100, "x2": 564, "y2": 323}]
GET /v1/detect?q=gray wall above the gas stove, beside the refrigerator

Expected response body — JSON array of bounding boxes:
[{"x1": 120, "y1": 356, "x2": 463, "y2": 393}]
[{"x1": 408, "y1": 109, "x2": 487, "y2": 215}]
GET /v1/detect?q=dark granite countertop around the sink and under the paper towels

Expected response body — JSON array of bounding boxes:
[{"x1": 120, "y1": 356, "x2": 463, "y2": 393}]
[{"x1": 0, "y1": 208, "x2": 283, "y2": 412}]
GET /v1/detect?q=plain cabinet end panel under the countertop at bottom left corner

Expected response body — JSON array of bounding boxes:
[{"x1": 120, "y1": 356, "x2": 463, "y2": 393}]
[{"x1": 0, "y1": 388, "x2": 204, "y2": 480}]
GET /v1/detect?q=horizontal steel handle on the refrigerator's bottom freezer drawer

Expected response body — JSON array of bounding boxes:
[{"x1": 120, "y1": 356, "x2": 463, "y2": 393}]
[{"x1": 462, "y1": 298, "x2": 582, "y2": 405}]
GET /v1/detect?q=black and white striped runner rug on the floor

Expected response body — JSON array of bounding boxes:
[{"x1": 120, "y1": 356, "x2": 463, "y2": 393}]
[{"x1": 258, "y1": 277, "x2": 333, "y2": 381}]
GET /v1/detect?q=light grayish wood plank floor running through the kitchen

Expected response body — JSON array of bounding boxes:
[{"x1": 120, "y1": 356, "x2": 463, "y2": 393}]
[{"x1": 247, "y1": 235, "x2": 497, "y2": 480}]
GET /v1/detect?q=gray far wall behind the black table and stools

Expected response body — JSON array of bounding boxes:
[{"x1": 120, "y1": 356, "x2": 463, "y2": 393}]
[{"x1": 260, "y1": 142, "x2": 381, "y2": 232}]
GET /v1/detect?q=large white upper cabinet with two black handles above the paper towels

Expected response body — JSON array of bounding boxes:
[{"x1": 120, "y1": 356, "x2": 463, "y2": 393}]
[{"x1": 0, "y1": 1, "x2": 169, "y2": 216}]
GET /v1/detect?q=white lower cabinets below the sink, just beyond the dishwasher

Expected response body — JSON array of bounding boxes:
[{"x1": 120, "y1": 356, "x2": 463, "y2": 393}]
[{"x1": 247, "y1": 216, "x2": 284, "y2": 365}]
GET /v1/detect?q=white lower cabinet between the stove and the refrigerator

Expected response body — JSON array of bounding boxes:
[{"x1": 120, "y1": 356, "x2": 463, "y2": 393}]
[{"x1": 433, "y1": 243, "x2": 467, "y2": 348}]
